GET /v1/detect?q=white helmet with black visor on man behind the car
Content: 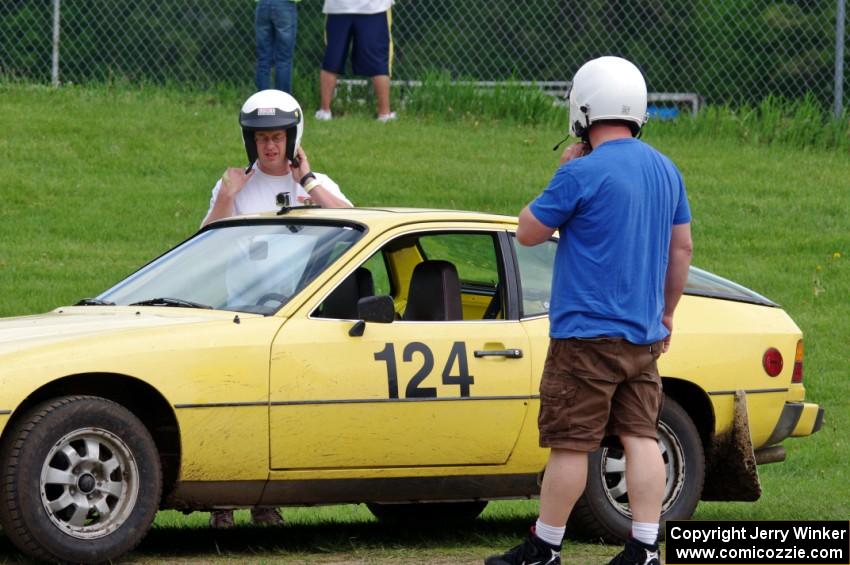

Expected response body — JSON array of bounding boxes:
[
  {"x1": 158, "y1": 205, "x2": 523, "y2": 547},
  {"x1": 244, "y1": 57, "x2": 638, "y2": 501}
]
[{"x1": 239, "y1": 89, "x2": 304, "y2": 167}]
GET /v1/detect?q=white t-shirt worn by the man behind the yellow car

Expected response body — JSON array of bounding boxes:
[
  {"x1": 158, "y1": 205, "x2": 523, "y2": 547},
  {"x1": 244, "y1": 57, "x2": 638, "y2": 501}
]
[{"x1": 201, "y1": 165, "x2": 351, "y2": 225}]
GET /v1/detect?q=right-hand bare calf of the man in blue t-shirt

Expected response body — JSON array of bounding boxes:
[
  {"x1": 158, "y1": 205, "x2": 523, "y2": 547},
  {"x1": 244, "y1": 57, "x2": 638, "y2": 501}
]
[{"x1": 620, "y1": 436, "x2": 666, "y2": 524}]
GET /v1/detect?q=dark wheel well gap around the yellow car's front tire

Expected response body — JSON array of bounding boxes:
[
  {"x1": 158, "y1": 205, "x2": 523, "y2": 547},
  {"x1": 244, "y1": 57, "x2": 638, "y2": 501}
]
[{"x1": 0, "y1": 373, "x2": 181, "y2": 499}]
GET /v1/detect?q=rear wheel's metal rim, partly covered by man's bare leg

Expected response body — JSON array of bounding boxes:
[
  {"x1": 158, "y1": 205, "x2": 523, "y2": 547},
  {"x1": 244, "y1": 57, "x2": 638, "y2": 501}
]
[{"x1": 600, "y1": 422, "x2": 685, "y2": 519}]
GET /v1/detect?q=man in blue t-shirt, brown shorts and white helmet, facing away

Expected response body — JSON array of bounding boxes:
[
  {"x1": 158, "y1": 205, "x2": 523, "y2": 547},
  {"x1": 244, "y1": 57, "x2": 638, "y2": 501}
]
[{"x1": 486, "y1": 57, "x2": 692, "y2": 565}]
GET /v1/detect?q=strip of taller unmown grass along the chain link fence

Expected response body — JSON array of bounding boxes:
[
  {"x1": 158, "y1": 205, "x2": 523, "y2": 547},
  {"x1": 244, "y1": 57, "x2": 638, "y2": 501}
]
[{"x1": 306, "y1": 73, "x2": 850, "y2": 151}]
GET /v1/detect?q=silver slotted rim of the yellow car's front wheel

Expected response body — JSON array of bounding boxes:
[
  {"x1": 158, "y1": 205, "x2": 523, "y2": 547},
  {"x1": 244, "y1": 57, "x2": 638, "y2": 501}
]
[{"x1": 40, "y1": 428, "x2": 139, "y2": 539}]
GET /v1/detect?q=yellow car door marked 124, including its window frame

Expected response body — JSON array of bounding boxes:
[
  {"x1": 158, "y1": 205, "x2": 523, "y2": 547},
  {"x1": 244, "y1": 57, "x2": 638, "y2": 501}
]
[{"x1": 270, "y1": 227, "x2": 531, "y2": 469}]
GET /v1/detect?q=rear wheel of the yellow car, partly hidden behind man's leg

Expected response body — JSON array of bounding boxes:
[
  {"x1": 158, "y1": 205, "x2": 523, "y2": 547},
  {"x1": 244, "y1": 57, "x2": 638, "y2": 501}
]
[{"x1": 570, "y1": 397, "x2": 705, "y2": 543}]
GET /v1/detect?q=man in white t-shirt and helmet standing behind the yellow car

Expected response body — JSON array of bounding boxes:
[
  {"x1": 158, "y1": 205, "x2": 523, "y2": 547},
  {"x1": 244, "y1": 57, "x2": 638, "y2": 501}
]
[{"x1": 201, "y1": 90, "x2": 351, "y2": 225}]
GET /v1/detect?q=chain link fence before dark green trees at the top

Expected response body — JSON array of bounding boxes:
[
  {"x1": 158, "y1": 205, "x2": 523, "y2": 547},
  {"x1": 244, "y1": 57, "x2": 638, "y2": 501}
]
[{"x1": 0, "y1": 0, "x2": 850, "y2": 113}]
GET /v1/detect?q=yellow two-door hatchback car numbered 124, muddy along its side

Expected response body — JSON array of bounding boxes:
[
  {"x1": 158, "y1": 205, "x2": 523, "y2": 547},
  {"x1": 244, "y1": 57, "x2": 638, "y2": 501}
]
[{"x1": 0, "y1": 208, "x2": 823, "y2": 562}]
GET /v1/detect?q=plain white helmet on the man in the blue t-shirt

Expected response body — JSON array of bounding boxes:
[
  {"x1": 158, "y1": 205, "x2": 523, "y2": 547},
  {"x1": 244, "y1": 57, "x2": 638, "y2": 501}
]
[{"x1": 569, "y1": 57, "x2": 647, "y2": 140}]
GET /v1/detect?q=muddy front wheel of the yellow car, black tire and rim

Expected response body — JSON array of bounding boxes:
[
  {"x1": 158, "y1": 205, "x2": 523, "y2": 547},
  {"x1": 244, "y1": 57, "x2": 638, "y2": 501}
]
[{"x1": 0, "y1": 396, "x2": 162, "y2": 563}]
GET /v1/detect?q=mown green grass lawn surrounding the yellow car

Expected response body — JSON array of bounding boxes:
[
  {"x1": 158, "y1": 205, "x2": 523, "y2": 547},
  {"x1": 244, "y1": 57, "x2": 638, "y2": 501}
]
[{"x1": 0, "y1": 84, "x2": 850, "y2": 563}]
